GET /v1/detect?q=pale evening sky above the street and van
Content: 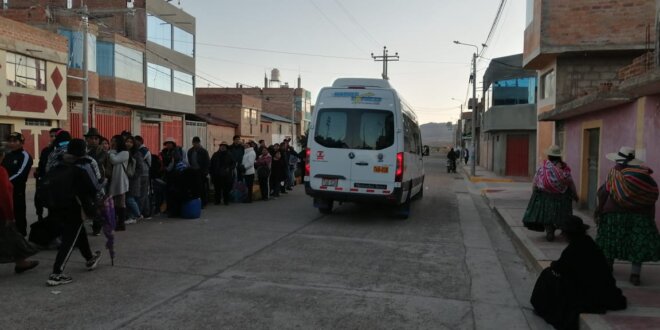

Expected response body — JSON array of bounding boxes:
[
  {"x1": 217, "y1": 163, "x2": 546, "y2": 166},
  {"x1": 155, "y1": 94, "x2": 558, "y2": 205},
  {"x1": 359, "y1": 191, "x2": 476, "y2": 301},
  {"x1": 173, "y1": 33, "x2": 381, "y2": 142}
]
[{"x1": 177, "y1": 0, "x2": 525, "y2": 123}]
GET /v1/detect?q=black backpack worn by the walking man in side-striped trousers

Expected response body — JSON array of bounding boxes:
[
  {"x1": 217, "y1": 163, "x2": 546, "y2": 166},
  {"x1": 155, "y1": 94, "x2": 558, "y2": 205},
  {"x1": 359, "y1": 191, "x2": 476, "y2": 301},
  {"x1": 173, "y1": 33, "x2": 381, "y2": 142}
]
[{"x1": 39, "y1": 164, "x2": 77, "y2": 209}]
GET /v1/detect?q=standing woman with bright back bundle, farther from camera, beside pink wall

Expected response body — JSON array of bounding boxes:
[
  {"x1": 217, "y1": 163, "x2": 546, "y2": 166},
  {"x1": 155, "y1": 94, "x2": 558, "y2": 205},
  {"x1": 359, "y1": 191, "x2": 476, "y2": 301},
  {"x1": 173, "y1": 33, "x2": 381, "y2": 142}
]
[{"x1": 523, "y1": 146, "x2": 577, "y2": 242}]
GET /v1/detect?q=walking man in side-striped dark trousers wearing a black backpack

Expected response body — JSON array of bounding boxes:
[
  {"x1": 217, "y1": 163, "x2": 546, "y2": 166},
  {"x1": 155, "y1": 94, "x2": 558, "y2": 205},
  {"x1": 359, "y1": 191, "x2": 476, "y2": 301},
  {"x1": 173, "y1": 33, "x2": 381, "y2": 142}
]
[{"x1": 43, "y1": 139, "x2": 101, "y2": 286}]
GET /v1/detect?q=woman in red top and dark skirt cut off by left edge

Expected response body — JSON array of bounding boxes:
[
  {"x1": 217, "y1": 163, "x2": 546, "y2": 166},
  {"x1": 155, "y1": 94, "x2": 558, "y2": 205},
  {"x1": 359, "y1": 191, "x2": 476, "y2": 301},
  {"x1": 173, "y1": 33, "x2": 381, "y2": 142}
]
[{"x1": 0, "y1": 145, "x2": 39, "y2": 274}]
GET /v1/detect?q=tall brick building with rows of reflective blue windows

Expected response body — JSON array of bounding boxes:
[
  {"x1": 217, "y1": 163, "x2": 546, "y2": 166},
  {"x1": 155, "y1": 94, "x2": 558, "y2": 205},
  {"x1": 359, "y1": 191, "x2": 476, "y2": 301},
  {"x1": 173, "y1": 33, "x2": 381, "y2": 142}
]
[{"x1": 1, "y1": 0, "x2": 195, "y2": 150}]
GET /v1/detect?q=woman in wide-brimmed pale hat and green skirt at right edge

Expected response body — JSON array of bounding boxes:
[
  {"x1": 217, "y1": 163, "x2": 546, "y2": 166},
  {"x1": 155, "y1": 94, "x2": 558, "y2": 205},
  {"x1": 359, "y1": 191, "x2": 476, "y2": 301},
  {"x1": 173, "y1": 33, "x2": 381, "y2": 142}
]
[{"x1": 596, "y1": 147, "x2": 660, "y2": 286}]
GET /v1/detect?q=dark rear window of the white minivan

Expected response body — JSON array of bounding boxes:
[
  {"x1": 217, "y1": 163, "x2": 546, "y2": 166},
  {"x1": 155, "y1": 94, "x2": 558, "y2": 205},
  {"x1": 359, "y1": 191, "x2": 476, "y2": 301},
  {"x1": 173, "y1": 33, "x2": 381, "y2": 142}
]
[{"x1": 314, "y1": 109, "x2": 394, "y2": 150}]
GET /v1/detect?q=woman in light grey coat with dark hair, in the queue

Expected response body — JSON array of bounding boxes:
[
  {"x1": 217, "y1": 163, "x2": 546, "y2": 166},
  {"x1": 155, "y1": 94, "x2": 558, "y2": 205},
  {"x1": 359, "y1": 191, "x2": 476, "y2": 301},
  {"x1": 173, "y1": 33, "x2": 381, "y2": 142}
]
[{"x1": 108, "y1": 135, "x2": 130, "y2": 231}]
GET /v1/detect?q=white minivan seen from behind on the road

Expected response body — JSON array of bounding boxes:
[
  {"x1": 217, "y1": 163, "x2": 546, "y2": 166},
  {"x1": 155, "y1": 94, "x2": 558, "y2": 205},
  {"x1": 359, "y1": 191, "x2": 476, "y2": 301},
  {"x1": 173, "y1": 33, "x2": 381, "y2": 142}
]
[{"x1": 305, "y1": 78, "x2": 424, "y2": 218}]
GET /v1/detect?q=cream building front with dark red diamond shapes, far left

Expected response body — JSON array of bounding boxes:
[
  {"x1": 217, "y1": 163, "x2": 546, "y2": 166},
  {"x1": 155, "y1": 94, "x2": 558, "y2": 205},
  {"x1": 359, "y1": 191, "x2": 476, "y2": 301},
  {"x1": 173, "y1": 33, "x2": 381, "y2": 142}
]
[{"x1": 0, "y1": 17, "x2": 68, "y2": 160}]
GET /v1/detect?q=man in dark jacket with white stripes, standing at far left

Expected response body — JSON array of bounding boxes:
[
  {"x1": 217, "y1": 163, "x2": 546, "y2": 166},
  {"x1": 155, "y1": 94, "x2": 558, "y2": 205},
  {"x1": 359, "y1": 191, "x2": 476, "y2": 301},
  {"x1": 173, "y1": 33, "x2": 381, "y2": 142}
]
[{"x1": 2, "y1": 133, "x2": 32, "y2": 236}]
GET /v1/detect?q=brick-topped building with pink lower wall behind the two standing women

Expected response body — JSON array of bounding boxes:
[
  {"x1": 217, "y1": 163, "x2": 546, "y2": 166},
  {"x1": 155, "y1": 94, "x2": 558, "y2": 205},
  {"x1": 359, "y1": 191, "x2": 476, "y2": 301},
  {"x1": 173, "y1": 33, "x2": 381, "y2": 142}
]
[{"x1": 523, "y1": 0, "x2": 660, "y2": 209}]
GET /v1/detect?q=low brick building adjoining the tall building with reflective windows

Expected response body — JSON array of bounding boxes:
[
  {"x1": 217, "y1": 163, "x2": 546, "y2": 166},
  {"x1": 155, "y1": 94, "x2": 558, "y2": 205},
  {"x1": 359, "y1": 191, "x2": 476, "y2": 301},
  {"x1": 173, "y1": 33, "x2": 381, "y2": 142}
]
[{"x1": 196, "y1": 88, "x2": 262, "y2": 140}]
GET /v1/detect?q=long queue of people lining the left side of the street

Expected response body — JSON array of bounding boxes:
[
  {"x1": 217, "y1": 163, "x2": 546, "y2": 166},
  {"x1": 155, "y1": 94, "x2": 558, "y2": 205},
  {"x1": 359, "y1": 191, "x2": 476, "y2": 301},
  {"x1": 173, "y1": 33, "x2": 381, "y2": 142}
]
[{"x1": 0, "y1": 128, "x2": 301, "y2": 286}]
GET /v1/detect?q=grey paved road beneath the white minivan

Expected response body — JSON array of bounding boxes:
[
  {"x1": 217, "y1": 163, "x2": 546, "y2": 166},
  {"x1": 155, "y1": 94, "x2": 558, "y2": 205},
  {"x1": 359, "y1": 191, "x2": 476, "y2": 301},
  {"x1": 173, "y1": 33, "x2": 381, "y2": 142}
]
[{"x1": 0, "y1": 157, "x2": 546, "y2": 329}]
